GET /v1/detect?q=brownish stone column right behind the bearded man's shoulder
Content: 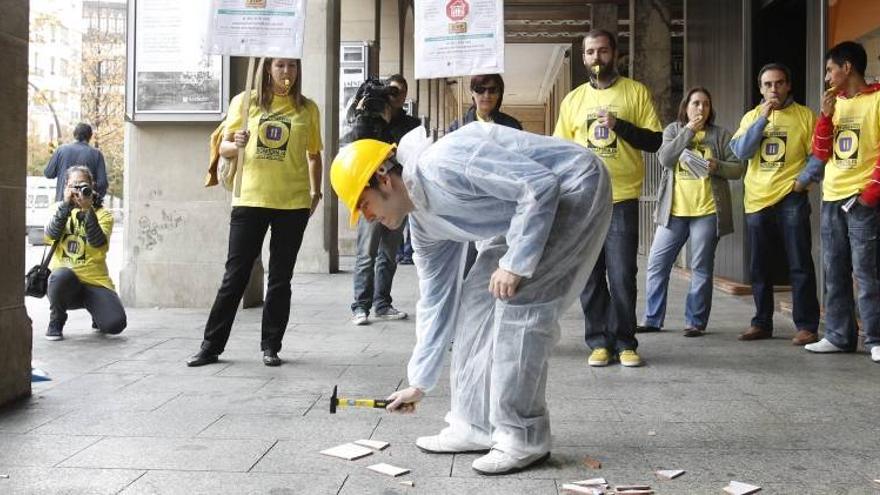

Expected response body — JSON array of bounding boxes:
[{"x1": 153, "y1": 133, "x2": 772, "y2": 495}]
[{"x1": 630, "y1": 0, "x2": 677, "y2": 122}]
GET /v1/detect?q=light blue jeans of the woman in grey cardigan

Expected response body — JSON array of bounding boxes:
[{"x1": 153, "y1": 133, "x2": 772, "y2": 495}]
[{"x1": 645, "y1": 214, "x2": 718, "y2": 330}]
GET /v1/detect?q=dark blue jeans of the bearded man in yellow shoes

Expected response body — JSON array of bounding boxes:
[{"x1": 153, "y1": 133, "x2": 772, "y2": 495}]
[{"x1": 581, "y1": 199, "x2": 639, "y2": 352}]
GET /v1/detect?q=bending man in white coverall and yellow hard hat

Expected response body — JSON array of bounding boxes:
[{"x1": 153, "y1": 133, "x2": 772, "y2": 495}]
[{"x1": 330, "y1": 122, "x2": 611, "y2": 474}]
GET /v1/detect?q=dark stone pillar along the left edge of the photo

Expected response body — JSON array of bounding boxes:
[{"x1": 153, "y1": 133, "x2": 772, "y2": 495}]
[{"x1": 0, "y1": 0, "x2": 32, "y2": 405}]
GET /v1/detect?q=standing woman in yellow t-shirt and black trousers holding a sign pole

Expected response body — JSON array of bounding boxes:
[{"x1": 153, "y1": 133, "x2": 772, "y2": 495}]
[{"x1": 187, "y1": 58, "x2": 322, "y2": 366}]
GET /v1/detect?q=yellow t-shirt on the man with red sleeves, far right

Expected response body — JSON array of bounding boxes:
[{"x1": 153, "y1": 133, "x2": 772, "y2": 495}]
[{"x1": 822, "y1": 91, "x2": 880, "y2": 201}]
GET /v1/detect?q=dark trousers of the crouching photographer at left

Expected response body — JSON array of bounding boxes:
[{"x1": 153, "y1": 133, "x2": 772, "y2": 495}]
[{"x1": 46, "y1": 268, "x2": 128, "y2": 334}]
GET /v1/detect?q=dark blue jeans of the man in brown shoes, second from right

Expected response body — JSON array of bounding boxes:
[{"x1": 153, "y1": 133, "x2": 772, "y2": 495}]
[{"x1": 746, "y1": 192, "x2": 819, "y2": 333}]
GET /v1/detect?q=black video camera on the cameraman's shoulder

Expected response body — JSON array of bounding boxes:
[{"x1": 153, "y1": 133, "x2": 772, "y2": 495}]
[{"x1": 342, "y1": 78, "x2": 400, "y2": 143}]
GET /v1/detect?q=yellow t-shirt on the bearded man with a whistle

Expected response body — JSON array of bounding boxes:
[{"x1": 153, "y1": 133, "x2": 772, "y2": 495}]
[{"x1": 553, "y1": 77, "x2": 660, "y2": 203}]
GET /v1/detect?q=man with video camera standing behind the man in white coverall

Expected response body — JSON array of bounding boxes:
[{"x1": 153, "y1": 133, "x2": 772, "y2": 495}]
[{"x1": 340, "y1": 74, "x2": 420, "y2": 325}]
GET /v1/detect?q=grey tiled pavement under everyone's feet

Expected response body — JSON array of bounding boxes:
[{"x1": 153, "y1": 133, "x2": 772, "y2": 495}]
[{"x1": 0, "y1": 260, "x2": 880, "y2": 495}]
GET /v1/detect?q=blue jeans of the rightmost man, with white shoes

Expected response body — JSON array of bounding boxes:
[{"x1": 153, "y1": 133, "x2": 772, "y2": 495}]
[{"x1": 821, "y1": 200, "x2": 880, "y2": 351}]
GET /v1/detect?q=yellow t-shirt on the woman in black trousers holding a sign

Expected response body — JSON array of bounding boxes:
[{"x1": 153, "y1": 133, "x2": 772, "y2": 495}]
[{"x1": 225, "y1": 91, "x2": 323, "y2": 210}]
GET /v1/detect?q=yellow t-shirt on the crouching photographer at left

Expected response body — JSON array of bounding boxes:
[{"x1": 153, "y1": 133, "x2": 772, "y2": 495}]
[{"x1": 46, "y1": 203, "x2": 116, "y2": 291}]
